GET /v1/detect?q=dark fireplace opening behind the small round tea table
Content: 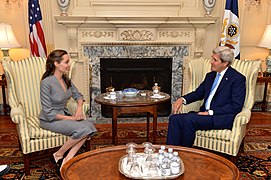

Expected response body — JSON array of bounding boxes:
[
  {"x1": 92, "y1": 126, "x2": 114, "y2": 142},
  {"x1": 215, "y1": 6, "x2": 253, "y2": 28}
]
[{"x1": 100, "y1": 58, "x2": 172, "y2": 117}]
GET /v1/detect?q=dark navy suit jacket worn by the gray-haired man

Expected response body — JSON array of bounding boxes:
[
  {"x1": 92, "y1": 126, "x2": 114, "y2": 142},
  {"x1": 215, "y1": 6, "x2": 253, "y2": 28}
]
[{"x1": 183, "y1": 67, "x2": 246, "y2": 129}]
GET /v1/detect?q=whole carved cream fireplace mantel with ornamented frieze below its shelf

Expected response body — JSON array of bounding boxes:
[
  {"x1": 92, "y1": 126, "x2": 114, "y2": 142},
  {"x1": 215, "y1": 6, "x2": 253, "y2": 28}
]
[{"x1": 55, "y1": 16, "x2": 218, "y2": 59}]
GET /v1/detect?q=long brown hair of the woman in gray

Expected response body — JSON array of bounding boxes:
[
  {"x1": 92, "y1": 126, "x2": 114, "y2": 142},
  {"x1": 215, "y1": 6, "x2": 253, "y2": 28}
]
[{"x1": 41, "y1": 49, "x2": 71, "y2": 88}]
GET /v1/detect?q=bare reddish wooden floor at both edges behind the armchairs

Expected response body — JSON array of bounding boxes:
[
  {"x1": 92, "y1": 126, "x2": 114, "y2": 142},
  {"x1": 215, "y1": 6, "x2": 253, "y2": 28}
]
[{"x1": 0, "y1": 112, "x2": 271, "y2": 130}]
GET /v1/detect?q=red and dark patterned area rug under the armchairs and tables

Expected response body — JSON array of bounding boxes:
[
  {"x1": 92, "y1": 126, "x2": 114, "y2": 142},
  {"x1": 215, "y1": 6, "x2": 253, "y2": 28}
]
[{"x1": 0, "y1": 123, "x2": 271, "y2": 180}]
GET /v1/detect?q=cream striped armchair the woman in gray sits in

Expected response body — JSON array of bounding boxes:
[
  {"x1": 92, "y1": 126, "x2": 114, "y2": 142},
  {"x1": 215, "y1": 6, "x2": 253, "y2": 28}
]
[{"x1": 2, "y1": 57, "x2": 89, "y2": 175}]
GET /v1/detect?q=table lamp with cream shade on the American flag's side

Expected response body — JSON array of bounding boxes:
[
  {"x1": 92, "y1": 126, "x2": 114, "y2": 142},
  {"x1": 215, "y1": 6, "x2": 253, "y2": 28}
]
[{"x1": 0, "y1": 23, "x2": 20, "y2": 60}]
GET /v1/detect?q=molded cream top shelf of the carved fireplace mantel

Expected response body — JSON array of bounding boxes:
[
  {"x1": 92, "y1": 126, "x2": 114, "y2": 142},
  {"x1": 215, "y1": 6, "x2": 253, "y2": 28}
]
[{"x1": 55, "y1": 16, "x2": 218, "y2": 28}]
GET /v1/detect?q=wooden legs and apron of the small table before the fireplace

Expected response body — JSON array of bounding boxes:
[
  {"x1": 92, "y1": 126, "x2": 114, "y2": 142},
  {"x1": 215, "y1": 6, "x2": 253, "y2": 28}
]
[{"x1": 112, "y1": 105, "x2": 157, "y2": 145}]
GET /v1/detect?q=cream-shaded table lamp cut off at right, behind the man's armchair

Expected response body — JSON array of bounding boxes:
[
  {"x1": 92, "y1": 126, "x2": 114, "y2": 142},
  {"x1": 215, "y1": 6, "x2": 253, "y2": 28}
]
[{"x1": 258, "y1": 24, "x2": 271, "y2": 76}]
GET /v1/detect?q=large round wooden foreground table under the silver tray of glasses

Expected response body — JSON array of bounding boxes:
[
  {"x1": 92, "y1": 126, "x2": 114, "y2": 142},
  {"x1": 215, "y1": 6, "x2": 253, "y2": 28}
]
[{"x1": 61, "y1": 145, "x2": 239, "y2": 180}]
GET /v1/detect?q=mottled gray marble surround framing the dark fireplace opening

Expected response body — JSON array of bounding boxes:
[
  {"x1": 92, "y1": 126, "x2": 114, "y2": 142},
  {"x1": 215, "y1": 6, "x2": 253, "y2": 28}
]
[{"x1": 83, "y1": 44, "x2": 189, "y2": 120}]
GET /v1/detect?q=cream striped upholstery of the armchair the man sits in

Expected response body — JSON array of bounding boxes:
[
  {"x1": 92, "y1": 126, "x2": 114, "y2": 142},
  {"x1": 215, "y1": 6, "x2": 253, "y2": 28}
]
[{"x1": 180, "y1": 58, "x2": 261, "y2": 156}]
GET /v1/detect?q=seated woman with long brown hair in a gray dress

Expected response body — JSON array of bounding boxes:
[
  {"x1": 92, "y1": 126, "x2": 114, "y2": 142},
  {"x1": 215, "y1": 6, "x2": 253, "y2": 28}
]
[{"x1": 39, "y1": 50, "x2": 97, "y2": 171}]
